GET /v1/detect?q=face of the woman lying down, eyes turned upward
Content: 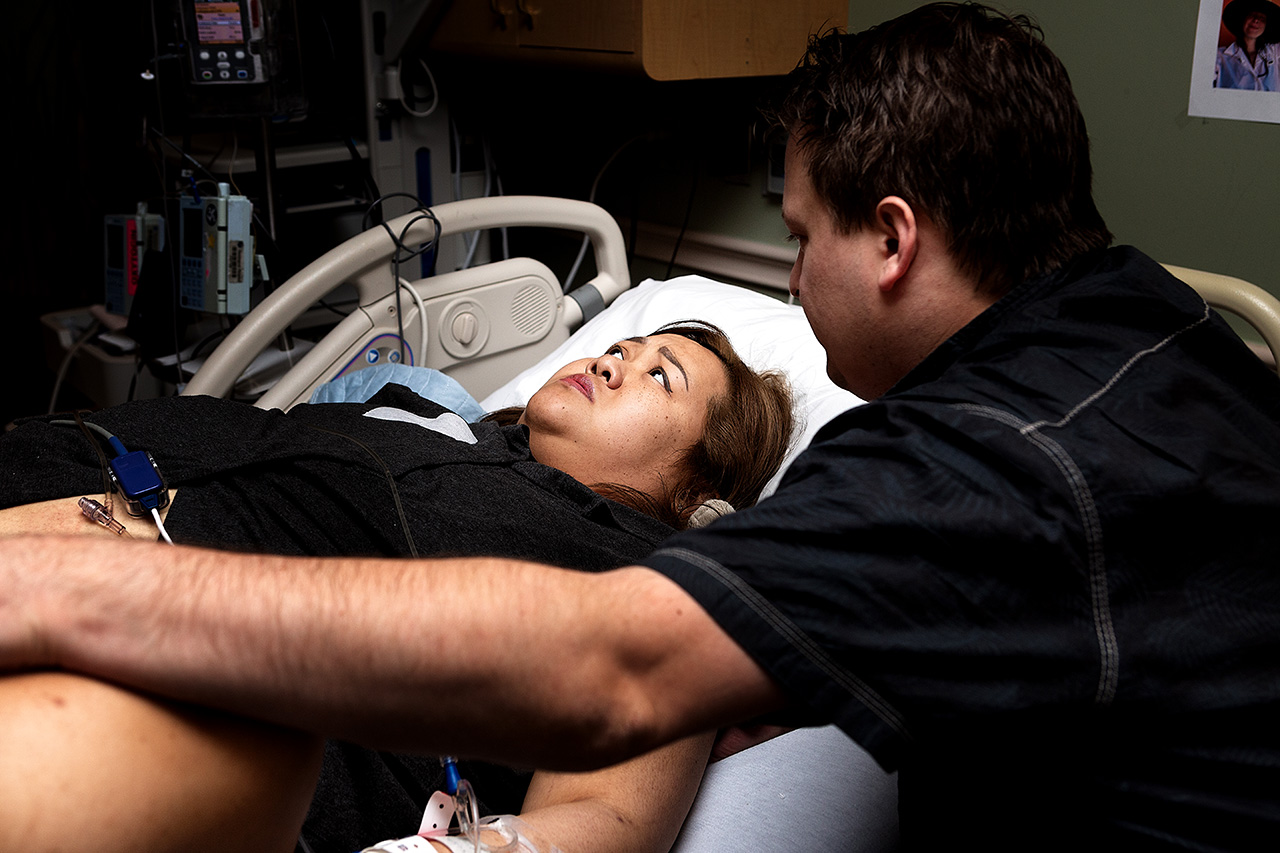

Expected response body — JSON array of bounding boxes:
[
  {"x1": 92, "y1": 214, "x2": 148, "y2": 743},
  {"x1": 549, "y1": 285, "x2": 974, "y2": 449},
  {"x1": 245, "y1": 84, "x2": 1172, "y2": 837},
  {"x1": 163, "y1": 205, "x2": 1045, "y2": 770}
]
[{"x1": 520, "y1": 334, "x2": 728, "y2": 496}]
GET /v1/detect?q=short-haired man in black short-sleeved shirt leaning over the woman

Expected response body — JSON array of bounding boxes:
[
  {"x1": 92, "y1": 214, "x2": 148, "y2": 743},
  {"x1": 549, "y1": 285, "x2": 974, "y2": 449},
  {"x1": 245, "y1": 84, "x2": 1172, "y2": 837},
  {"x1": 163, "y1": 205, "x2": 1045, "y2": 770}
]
[{"x1": 0, "y1": 4, "x2": 1280, "y2": 849}]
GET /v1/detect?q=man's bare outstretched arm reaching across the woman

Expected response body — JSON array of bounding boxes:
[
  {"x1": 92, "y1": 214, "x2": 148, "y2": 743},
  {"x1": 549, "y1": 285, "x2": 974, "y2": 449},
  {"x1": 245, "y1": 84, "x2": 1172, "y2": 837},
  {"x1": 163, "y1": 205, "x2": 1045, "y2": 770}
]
[{"x1": 0, "y1": 538, "x2": 782, "y2": 770}]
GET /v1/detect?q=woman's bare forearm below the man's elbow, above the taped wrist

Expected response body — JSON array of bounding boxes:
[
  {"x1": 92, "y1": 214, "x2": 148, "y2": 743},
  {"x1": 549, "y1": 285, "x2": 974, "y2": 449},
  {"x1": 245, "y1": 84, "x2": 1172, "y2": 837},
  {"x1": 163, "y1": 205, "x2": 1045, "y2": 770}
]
[{"x1": 520, "y1": 734, "x2": 713, "y2": 853}]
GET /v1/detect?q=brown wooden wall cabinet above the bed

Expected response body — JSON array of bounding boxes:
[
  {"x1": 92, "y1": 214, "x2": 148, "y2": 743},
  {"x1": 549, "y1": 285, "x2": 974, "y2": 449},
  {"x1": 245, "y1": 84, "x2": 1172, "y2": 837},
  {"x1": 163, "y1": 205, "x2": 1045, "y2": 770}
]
[{"x1": 430, "y1": 0, "x2": 847, "y2": 79}]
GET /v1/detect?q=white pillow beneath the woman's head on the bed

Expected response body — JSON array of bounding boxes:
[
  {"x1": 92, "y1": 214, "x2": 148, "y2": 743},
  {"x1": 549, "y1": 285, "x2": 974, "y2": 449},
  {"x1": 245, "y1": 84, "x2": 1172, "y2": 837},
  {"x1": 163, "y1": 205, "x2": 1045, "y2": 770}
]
[{"x1": 480, "y1": 275, "x2": 863, "y2": 497}]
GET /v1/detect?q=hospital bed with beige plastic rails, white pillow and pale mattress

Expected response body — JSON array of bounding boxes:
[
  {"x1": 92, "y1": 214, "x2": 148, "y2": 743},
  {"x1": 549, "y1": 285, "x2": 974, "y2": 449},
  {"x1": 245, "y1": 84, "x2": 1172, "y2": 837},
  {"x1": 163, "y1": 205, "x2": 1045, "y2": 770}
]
[{"x1": 184, "y1": 197, "x2": 1280, "y2": 853}]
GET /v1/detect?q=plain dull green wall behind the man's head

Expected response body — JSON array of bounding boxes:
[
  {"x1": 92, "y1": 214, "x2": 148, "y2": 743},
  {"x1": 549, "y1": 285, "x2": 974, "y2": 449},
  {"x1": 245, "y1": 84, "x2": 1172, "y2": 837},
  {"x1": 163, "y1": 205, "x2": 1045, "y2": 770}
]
[{"x1": 691, "y1": 0, "x2": 1280, "y2": 302}]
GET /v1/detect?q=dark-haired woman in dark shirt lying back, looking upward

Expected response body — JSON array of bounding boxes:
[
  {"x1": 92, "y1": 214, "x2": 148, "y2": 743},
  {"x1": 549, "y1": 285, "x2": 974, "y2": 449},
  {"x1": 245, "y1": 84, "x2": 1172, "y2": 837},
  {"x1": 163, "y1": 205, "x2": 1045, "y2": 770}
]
[{"x1": 0, "y1": 317, "x2": 791, "y2": 852}]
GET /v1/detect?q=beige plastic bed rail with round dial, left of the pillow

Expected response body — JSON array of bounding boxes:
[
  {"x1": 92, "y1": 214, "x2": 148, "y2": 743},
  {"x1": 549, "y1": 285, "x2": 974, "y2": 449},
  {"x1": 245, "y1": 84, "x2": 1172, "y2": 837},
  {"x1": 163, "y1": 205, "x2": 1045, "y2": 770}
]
[{"x1": 182, "y1": 196, "x2": 631, "y2": 409}]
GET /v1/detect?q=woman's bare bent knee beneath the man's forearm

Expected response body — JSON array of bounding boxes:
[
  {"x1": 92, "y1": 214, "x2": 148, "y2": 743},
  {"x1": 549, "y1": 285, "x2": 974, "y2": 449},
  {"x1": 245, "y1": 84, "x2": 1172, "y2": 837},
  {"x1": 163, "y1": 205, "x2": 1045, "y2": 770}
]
[{"x1": 0, "y1": 672, "x2": 321, "y2": 853}]
